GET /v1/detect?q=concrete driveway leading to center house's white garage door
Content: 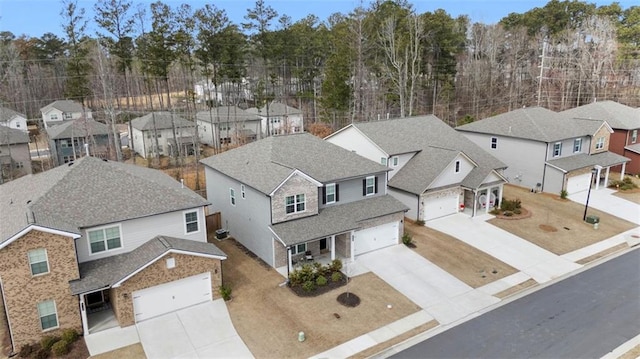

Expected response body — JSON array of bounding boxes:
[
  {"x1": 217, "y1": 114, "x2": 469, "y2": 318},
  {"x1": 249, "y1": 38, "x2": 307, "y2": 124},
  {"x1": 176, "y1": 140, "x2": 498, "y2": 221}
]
[{"x1": 356, "y1": 244, "x2": 500, "y2": 324}]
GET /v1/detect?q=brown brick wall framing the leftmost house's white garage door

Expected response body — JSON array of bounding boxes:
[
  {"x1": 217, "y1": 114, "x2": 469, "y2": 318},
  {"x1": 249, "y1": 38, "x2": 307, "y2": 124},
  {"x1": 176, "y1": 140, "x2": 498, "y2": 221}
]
[{"x1": 110, "y1": 253, "x2": 222, "y2": 327}]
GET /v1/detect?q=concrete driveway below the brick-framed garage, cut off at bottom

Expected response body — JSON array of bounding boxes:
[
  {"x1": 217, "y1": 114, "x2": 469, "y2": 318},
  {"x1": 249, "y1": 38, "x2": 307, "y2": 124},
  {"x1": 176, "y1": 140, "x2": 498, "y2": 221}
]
[{"x1": 137, "y1": 299, "x2": 253, "y2": 359}]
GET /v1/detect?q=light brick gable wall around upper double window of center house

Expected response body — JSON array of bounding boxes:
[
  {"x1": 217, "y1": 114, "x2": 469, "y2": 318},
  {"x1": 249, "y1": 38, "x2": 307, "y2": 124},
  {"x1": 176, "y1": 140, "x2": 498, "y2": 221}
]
[{"x1": 271, "y1": 175, "x2": 318, "y2": 223}]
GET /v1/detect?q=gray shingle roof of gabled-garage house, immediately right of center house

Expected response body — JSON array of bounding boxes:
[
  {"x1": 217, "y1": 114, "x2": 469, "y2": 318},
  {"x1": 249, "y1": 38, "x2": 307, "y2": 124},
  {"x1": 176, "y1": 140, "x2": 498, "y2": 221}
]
[{"x1": 353, "y1": 115, "x2": 507, "y2": 194}]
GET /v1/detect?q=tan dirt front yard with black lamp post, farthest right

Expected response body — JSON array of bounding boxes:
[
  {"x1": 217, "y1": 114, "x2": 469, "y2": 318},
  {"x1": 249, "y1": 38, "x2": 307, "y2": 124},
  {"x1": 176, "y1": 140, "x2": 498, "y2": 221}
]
[{"x1": 489, "y1": 185, "x2": 636, "y2": 255}]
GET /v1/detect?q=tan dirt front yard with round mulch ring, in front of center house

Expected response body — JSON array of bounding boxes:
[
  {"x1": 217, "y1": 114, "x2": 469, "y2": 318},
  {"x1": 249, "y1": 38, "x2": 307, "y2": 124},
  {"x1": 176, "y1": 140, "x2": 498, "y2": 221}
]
[{"x1": 213, "y1": 239, "x2": 430, "y2": 358}]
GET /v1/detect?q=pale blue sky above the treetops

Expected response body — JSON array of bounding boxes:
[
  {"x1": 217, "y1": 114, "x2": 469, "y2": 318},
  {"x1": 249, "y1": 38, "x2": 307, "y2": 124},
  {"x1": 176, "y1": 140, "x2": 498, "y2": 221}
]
[{"x1": 0, "y1": 0, "x2": 638, "y2": 37}]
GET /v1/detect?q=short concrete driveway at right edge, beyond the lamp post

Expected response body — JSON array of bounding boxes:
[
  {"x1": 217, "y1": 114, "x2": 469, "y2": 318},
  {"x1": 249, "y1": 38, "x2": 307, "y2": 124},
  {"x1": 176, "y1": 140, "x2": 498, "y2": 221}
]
[{"x1": 569, "y1": 188, "x2": 640, "y2": 225}]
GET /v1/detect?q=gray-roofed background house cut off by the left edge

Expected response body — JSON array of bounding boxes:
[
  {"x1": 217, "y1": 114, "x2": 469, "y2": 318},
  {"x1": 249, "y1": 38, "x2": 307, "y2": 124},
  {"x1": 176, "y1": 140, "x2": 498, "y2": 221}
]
[{"x1": 0, "y1": 126, "x2": 31, "y2": 183}]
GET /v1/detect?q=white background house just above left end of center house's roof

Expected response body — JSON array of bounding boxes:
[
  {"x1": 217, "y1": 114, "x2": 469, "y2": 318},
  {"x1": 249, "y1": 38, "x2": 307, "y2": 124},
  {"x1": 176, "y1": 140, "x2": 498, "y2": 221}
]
[{"x1": 196, "y1": 106, "x2": 262, "y2": 146}]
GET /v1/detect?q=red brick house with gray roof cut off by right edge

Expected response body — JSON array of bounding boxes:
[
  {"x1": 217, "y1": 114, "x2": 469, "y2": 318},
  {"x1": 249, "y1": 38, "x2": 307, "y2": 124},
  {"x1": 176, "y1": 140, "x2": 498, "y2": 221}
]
[{"x1": 561, "y1": 101, "x2": 640, "y2": 174}]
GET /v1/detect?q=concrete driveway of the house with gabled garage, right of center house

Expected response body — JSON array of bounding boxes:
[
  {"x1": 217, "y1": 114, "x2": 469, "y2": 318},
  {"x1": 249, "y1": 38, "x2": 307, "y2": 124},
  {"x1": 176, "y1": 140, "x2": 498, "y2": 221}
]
[{"x1": 426, "y1": 213, "x2": 582, "y2": 283}]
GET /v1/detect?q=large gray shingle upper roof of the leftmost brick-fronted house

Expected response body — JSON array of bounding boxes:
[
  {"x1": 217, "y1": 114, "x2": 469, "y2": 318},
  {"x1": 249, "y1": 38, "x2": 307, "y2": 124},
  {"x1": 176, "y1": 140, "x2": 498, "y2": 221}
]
[{"x1": 0, "y1": 157, "x2": 209, "y2": 242}]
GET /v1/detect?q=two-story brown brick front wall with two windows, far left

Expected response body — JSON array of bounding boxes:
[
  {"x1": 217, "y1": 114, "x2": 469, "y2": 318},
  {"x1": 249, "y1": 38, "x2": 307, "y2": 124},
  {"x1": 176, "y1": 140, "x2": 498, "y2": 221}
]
[{"x1": 0, "y1": 230, "x2": 82, "y2": 351}]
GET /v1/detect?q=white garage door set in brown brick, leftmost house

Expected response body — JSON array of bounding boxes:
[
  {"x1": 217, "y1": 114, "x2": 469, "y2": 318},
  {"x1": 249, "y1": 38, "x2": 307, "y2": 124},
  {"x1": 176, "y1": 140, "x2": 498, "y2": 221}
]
[{"x1": 133, "y1": 272, "x2": 212, "y2": 322}]
